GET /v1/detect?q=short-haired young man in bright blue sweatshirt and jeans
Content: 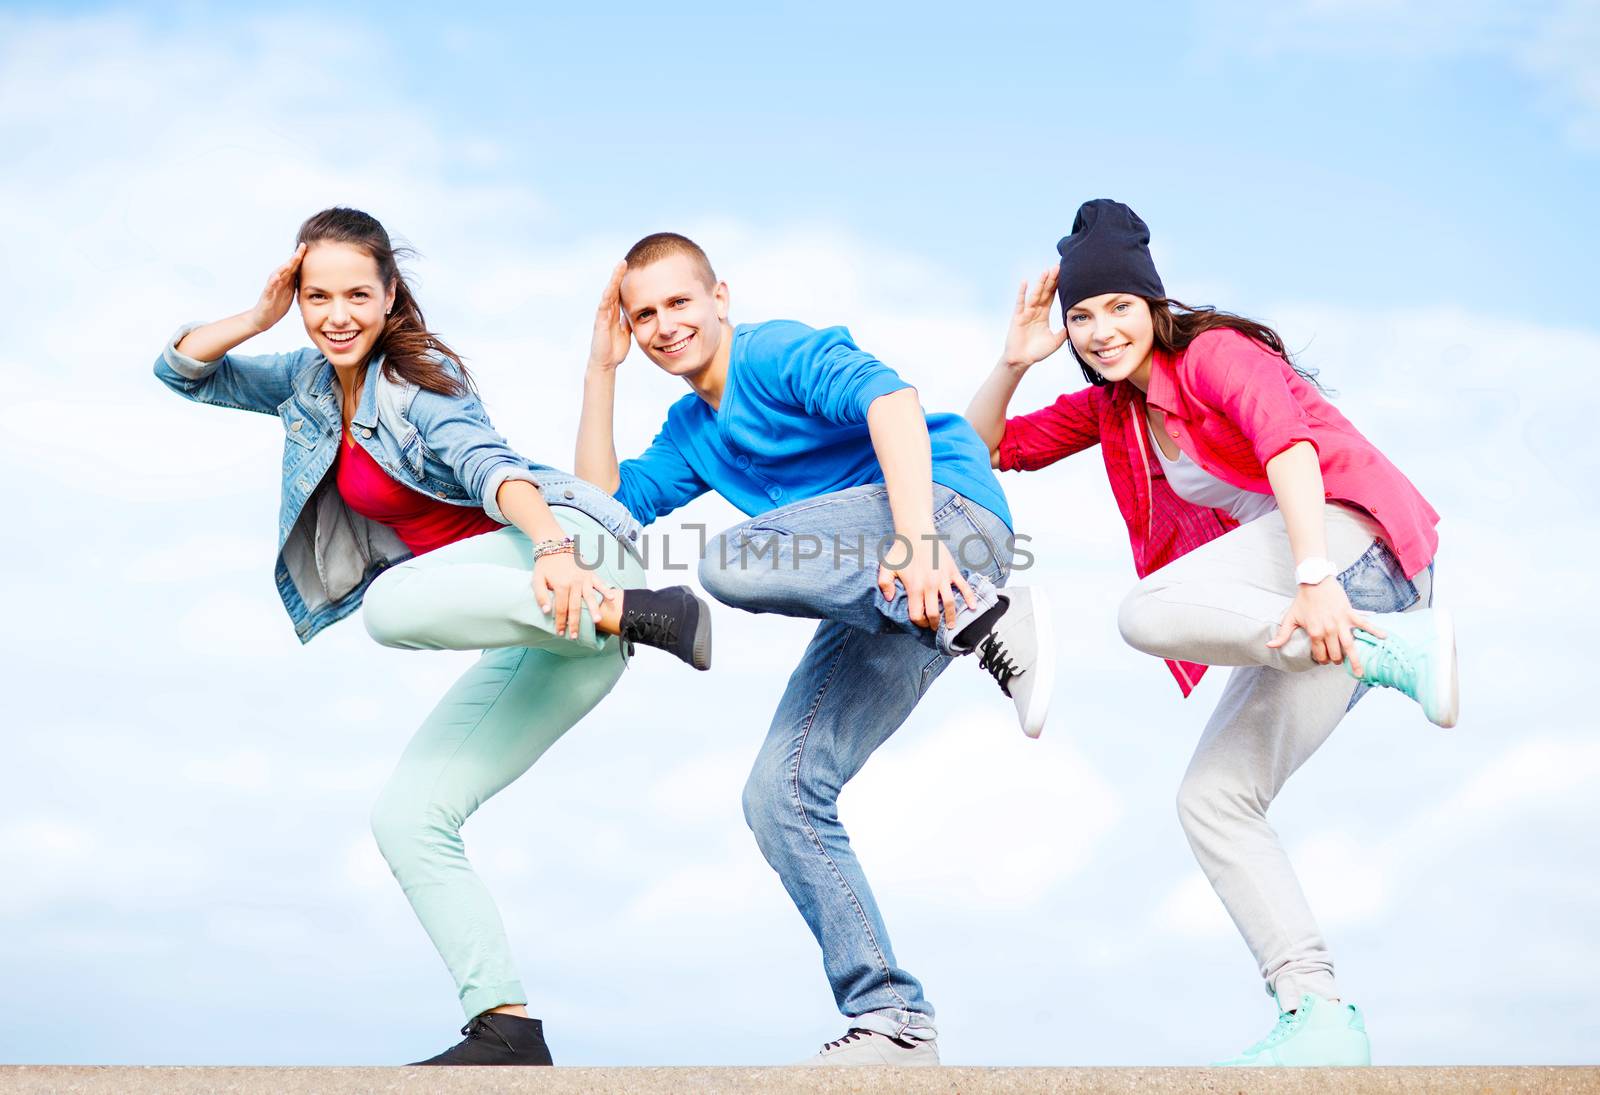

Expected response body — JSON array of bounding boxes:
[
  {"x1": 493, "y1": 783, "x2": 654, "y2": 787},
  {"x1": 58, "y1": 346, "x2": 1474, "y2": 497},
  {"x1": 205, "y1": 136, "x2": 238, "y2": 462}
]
[{"x1": 576, "y1": 232, "x2": 1054, "y2": 1065}]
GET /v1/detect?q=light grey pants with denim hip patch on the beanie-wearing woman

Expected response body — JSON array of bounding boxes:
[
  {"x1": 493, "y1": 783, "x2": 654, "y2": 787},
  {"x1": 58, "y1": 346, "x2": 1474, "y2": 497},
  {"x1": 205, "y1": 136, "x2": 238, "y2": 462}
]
[{"x1": 1118, "y1": 503, "x2": 1432, "y2": 1005}]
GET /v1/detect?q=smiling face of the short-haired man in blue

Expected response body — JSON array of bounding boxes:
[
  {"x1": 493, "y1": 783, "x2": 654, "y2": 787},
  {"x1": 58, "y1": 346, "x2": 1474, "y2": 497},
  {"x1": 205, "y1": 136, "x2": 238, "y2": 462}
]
[{"x1": 622, "y1": 253, "x2": 728, "y2": 376}]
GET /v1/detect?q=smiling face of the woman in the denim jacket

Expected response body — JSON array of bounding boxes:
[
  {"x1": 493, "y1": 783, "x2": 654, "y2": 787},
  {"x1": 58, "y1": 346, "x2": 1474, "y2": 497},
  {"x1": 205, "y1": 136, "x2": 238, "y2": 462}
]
[{"x1": 299, "y1": 242, "x2": 395, "y2": 367}]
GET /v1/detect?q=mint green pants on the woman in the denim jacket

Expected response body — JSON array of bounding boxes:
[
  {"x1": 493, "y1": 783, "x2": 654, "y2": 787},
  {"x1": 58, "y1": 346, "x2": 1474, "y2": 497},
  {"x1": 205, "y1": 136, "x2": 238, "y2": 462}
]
[{"x1": 363, "y1": 506, "x2": 645, "y2": 1018}]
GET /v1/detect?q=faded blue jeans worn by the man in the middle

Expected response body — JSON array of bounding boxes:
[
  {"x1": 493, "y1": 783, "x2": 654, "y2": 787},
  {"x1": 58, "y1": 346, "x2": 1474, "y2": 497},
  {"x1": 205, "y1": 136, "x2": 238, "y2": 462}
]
[{"x1": 699, "y1": 485, "x2": 1014, "y2": 1037}]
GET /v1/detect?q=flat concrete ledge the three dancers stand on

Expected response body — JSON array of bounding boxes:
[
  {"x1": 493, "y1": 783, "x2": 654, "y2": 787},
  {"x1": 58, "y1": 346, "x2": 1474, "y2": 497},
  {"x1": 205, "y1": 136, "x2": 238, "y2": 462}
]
[{"x1": 0, "y1": 1065, "x2": 1600, "y2": 1095}]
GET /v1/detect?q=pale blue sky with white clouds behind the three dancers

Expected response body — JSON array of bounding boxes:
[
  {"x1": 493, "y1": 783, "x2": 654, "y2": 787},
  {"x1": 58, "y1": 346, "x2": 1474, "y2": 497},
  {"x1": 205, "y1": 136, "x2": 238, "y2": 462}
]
[{"x1": 0, "y1": 0, "x2": 1600, "y2": 1065}]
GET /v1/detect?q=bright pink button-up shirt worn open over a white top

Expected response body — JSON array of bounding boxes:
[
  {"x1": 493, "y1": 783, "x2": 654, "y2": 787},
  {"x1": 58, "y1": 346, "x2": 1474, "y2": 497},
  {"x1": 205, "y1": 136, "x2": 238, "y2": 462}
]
[{"x1": 1000, "y1": 330, "x2": 1438, "y2": 696}]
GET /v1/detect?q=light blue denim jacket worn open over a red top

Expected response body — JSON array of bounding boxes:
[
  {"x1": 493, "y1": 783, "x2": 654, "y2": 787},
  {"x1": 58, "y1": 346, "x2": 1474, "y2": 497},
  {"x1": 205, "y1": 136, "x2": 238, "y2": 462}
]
[{"x1": 155, "y1": 323, "x2": 640, "y2": 642}]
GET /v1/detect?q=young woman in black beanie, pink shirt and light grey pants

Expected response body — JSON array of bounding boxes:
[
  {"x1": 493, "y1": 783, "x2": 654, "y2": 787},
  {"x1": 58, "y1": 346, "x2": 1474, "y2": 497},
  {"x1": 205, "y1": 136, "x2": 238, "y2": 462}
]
[{"x1": 966, "y1": 199, "x2": 1458, "y2": 1065}]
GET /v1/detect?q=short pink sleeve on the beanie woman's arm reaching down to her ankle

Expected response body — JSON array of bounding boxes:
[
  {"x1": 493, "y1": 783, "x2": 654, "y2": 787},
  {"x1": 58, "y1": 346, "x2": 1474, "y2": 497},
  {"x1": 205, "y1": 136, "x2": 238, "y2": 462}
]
[{"x1": 1179, "y1": 330, "x2": 1317, "y2": 467}]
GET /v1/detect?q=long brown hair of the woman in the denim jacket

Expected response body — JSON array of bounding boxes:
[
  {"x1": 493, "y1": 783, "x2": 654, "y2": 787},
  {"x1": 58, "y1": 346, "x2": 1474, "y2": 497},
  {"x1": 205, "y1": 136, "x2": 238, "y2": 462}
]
[{"x1": 294, "y1": 208, "x2": 472, "y2": 395}]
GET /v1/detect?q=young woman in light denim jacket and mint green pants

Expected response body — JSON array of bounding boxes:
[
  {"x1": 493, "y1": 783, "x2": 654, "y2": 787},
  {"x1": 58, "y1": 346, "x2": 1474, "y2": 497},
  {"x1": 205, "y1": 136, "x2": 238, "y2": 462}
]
[{"x1": 155, "y1": 208, "x2": 710, "y2": 1065}]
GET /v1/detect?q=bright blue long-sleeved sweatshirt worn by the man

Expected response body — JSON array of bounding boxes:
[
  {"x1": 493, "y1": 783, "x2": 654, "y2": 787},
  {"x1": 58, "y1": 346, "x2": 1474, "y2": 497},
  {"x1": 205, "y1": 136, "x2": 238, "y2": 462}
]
[{"x1": 616, "y1": 320, "x2": 1011, "y2": 525}]
